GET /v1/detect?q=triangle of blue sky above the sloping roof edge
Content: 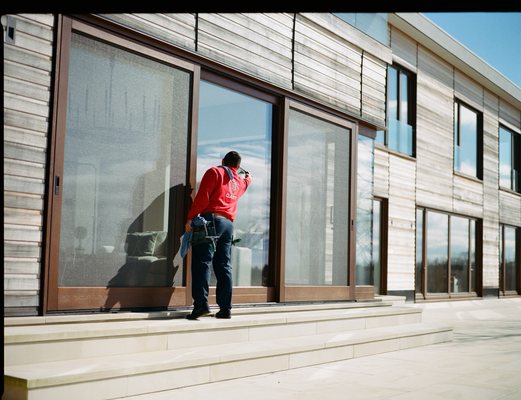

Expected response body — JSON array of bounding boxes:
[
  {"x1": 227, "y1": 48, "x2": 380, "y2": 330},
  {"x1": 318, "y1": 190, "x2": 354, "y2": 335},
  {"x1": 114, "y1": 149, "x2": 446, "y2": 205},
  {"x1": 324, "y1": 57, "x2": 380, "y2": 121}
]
[{"x1": 422, "y1": 12, "x2": 521, "y2": 88}]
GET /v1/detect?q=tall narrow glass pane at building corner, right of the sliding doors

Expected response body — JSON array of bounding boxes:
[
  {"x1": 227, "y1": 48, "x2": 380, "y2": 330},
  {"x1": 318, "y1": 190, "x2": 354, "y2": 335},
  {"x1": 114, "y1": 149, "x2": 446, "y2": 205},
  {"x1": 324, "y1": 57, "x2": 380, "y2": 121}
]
[{"x1": 356, "y1": 136, "x2": 378, "y2": 285}]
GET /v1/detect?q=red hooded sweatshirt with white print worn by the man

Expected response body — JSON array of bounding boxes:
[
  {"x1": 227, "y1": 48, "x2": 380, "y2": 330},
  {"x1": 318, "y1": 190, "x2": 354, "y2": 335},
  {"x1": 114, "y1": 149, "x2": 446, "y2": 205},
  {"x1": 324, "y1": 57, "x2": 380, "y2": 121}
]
[{"x1": 187, "y1": 166, "x2": 251, "y2": 221}]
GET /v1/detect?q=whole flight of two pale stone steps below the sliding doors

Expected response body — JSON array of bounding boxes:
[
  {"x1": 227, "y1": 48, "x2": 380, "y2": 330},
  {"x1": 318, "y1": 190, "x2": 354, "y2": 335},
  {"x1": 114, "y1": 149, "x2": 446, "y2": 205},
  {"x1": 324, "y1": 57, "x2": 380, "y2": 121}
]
[{"x1": 3, "y1": 305, "x2": 452, "y2": 400}]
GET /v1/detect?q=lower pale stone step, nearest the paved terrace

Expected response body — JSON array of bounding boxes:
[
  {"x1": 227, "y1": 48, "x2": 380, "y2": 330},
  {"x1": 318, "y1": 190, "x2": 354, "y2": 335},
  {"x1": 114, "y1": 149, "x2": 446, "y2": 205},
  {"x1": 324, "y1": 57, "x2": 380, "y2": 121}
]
[{"x1": 4, "y1": 323, "x2": 452, "y2": 400}]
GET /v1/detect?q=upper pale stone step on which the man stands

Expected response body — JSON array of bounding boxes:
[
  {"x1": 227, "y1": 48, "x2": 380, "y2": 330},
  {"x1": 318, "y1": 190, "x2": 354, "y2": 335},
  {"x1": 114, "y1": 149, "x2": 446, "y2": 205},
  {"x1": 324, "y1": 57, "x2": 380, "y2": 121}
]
[{"x1": 4, "y1": 303, "x2": 421, "y2": 366}]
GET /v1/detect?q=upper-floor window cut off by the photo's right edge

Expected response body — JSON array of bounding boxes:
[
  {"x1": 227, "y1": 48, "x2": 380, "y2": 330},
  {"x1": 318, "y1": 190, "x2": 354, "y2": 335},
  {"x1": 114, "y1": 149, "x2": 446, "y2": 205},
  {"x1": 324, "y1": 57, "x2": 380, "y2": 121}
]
[{"x1": 499, "y1": 126, "x2": 521, "y2": 193}]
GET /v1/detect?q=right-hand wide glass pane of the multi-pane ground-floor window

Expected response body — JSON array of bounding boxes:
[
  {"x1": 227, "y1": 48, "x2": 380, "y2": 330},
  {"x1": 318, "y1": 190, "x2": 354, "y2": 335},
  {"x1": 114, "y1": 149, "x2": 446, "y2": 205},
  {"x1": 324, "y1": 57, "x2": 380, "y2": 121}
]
[{"x1": 450, "y1": 216, "x2": 470, "y2": 293}]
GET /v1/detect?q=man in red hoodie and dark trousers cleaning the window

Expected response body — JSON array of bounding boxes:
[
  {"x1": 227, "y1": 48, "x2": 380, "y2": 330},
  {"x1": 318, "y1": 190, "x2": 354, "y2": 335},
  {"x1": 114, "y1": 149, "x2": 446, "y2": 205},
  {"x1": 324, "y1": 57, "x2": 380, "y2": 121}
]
[{"x1": 185, "y1": 151, "x2": 251, "y2": 320}]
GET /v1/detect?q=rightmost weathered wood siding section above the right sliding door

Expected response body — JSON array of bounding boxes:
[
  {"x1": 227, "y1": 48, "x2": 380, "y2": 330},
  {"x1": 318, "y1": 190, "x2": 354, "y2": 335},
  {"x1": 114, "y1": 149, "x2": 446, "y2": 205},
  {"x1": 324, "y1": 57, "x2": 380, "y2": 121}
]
[{"x1": 293, "y1": 13, "x2": 391, "y2": 125}]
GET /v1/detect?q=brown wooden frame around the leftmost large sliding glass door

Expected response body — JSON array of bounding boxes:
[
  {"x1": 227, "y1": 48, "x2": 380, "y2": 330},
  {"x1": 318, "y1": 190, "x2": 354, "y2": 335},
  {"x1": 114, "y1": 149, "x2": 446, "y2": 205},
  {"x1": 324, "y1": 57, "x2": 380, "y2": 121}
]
[{"x1": 41, "y1": 16, "x2": 200, "y2": 314}]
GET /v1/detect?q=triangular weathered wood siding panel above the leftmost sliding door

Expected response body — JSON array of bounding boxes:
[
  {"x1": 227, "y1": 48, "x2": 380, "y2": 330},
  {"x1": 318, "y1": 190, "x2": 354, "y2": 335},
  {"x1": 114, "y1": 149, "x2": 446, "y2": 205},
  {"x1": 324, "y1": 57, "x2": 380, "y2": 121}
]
[{"x1": 100, "y1": 13, "x2": 195, "y2": 51}]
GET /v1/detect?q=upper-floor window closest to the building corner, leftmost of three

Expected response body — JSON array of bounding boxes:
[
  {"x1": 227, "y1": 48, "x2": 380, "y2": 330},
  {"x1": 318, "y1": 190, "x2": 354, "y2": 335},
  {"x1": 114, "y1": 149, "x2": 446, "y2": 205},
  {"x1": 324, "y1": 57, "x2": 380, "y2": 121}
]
[{"x1": 376, "y1": 65, "x2": 416, "y2": 156}]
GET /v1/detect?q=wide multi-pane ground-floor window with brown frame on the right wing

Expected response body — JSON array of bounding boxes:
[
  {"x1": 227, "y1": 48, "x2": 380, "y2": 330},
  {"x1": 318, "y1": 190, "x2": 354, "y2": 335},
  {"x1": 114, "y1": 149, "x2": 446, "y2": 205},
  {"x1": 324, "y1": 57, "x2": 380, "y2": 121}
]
[{"x1": 415, "y1": 208, "x2": 477, "y2": 297}]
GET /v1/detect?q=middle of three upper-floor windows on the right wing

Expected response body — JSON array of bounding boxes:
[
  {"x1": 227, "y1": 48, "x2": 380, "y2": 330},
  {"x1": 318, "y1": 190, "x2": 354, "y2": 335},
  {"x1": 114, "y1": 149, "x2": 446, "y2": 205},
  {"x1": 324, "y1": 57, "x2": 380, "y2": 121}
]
[{"x1": 454, "y1": 100, "x2": 483, "y2": 179}]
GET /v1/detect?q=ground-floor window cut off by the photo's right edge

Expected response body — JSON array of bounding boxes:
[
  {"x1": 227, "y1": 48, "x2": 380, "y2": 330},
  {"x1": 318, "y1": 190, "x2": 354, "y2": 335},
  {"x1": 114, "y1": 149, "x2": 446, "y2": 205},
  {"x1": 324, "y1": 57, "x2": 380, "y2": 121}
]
[{"x1": 499, "y1": 224, "x2": 521, "y2": 295}]
